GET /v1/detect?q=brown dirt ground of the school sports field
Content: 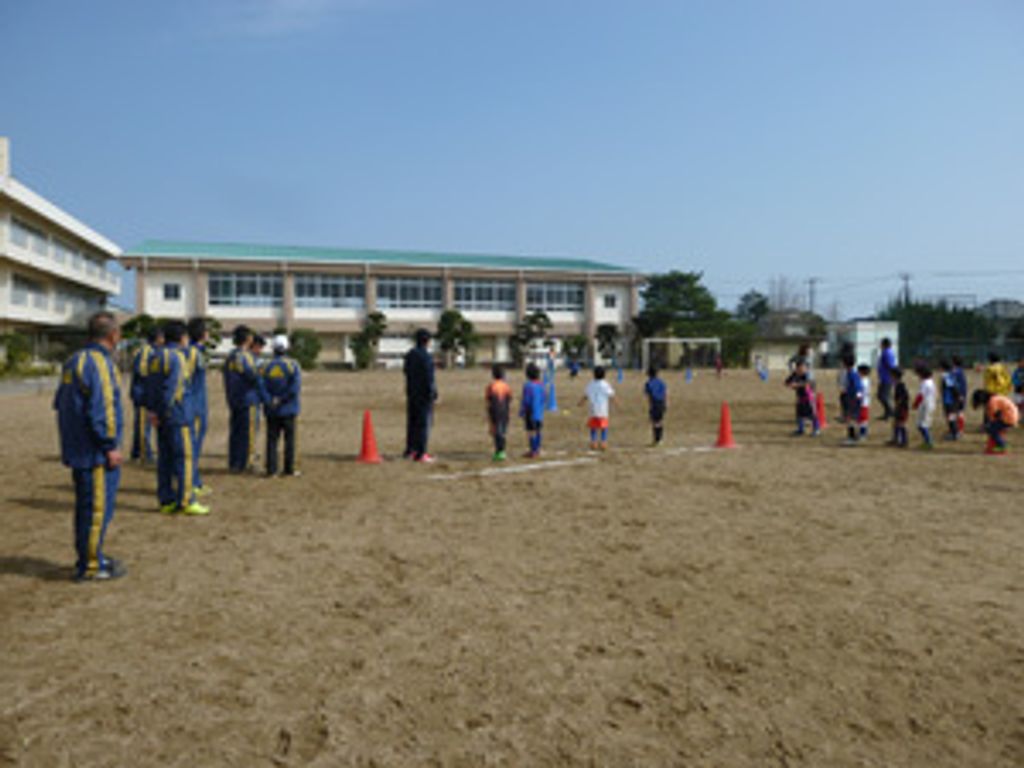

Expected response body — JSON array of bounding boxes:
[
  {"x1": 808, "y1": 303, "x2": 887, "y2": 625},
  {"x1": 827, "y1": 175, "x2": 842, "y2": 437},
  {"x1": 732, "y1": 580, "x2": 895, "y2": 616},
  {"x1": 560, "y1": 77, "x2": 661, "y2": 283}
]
[{"x1": 0, "y1": 372, "x2": 1024, "y2": 768}]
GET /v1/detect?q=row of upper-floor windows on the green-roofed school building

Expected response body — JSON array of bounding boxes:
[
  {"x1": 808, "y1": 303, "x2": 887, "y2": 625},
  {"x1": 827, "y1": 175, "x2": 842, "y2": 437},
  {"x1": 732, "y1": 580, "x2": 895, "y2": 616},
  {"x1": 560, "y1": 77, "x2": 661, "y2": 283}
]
[{"x1": 195, "y1": 272, "x2": 616, "y2": 312}]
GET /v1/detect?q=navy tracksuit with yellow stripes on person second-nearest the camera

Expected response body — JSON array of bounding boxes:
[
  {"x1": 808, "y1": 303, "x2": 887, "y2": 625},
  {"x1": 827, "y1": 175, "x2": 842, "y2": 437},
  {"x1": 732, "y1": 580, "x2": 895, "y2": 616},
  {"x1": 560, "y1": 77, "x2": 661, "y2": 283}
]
[{"x1": 150, "y1": 344, "x2": 196, "y2": 509}]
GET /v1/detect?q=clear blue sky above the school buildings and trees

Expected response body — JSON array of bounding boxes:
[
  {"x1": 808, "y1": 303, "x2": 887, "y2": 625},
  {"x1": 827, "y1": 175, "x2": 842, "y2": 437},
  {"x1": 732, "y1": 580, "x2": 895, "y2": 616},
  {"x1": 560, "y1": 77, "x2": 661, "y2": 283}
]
[{"x1": 0, "y1": 0, "x2": 1024, "y2": 315}]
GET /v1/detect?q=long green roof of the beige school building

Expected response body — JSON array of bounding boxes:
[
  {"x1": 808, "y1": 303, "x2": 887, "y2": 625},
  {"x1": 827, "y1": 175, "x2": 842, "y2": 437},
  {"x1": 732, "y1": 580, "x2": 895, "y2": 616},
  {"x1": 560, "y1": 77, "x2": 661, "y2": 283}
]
[{"x1": 125, "y1": 240, "x2": 634, "y2": 273}]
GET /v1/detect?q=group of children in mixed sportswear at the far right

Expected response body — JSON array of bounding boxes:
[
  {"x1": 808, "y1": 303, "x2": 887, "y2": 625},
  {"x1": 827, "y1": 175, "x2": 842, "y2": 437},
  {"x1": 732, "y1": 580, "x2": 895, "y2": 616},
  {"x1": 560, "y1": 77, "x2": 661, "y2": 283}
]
[{"x1": 785, "y1": 352, "x2": 1024, "y2": 454}]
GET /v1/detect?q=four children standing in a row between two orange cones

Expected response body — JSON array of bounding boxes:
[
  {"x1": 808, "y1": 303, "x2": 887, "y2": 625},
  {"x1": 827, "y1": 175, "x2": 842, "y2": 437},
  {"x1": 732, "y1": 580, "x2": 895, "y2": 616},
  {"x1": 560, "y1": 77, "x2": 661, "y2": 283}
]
[{"x1": 483, "y1": 362, "x2": 668, "y2": 462}]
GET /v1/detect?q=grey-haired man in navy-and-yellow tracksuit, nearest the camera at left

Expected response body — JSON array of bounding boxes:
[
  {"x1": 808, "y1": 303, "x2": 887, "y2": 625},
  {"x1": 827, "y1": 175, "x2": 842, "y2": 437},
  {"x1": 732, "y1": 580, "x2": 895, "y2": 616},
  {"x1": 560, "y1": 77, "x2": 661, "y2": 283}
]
[{"x1": 53, "y1": 311, "x2": 125, "y2": 581}]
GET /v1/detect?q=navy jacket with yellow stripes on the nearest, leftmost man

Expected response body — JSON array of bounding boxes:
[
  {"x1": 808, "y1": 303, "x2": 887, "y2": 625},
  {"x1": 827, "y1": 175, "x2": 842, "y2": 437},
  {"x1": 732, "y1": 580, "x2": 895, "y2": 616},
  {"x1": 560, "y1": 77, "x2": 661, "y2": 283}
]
[{"x1": 53, "y1": 344, "x2": 124, "y2": 469}]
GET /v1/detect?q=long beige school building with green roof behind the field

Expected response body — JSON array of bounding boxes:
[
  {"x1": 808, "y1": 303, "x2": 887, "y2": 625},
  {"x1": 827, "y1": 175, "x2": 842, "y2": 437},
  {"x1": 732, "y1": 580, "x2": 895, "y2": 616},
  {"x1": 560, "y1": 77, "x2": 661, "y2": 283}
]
[{"x1": 122, "y1": 241, "x2": 643, "y2": 364}]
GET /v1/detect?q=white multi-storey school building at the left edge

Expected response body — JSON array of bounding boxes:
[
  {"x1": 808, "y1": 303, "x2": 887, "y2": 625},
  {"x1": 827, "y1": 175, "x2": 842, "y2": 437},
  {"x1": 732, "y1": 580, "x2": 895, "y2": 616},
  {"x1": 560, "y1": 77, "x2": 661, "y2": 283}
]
[{"x1": 0, "y1": 137, "x2": 121, "y2": 356}]
